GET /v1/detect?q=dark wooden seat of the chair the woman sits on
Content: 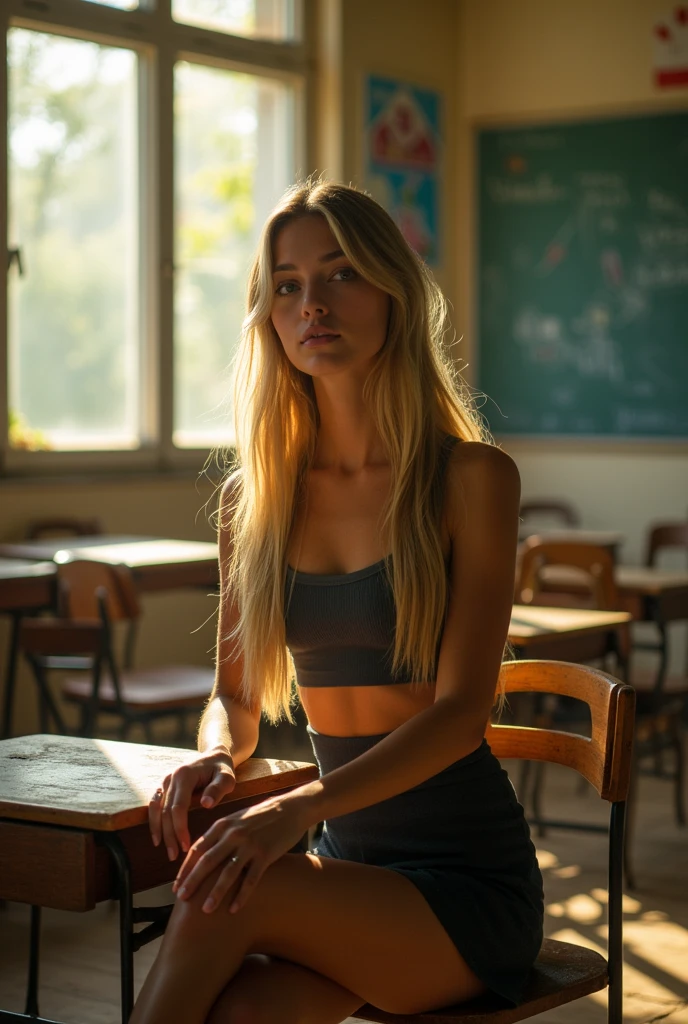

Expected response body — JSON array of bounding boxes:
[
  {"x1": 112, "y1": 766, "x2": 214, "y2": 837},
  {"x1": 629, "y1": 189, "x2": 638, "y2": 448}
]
[{"x1": 351, "y1": 939, "x2": 608, "y2": 1024}]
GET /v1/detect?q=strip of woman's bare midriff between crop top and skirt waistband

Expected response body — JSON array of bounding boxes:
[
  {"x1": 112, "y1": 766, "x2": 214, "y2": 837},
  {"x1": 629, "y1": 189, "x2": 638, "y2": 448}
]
[{"x1": 299, "y1": 683, "x2": 435, "y2": 736}]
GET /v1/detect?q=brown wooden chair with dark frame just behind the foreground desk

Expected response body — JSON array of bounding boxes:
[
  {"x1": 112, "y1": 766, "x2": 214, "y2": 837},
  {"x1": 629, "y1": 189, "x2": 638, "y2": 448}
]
[{"x1": 19, "y1": 559, "x2": 215, "y2": 742}]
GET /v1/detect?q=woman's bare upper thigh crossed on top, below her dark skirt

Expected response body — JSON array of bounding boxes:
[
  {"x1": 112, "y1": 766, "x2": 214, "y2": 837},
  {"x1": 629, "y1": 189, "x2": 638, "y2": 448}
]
[{"x1": 175, "y1": 854, "x2": 484, "y2": 1013}]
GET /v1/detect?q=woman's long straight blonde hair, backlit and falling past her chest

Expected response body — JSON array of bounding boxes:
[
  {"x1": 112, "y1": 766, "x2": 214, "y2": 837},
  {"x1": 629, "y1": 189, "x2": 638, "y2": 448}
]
[{"x1": 222, "y1": 178, "x2": 489, "y2": 722}]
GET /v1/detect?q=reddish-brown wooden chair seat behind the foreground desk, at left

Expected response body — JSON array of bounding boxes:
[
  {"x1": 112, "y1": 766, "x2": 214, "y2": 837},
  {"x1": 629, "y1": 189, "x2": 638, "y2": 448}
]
[{"x1": 61, "y1": 665, "x2": 215, "y2": 711}]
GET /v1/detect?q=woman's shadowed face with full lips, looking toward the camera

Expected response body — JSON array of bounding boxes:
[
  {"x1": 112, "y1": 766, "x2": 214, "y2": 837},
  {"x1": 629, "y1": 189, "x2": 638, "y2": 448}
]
[{"x1": 272, "y1": 214, "x2": 390, "y2": 377}]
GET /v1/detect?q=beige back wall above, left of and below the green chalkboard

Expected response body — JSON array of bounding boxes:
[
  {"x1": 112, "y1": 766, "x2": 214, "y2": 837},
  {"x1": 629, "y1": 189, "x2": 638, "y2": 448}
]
[{"x1": 458, "y1": 0, "x2": 688, "y2": 577}]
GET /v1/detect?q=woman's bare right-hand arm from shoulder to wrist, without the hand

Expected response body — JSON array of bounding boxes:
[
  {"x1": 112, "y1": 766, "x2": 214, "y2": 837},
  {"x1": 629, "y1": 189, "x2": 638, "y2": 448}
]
[{"x1": 284, "y1": 442, "x2": 520, "y2": 826}]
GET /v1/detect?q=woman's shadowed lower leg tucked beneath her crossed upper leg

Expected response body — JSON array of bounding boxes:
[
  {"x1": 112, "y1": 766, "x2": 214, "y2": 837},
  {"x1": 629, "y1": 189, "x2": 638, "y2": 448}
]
[{"x1": 206, "y1": 953, "x2": 361, "y2": 1024}]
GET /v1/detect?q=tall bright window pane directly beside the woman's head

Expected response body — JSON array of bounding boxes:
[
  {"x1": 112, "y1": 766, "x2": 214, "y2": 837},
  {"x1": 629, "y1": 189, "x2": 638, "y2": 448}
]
[{"x1": 174, "y1": 62, "x2": 294, "y2": 446}]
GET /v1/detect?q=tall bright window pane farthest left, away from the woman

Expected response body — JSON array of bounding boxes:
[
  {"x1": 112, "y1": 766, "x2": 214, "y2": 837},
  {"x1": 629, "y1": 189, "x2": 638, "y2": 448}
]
[{"x1": 9, "y1": 29, "x2": 138, "y2": 450}]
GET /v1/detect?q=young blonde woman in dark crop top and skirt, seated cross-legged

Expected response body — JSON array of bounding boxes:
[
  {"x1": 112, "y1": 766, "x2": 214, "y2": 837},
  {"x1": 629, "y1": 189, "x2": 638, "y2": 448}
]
[{"x1": 132, "y1": 181, "x2": 543, "y2": 1024}]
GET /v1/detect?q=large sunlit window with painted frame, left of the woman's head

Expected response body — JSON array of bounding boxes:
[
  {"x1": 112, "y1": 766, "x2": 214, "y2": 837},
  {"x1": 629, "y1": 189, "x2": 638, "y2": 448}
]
[{"x1": 0, "y1": 0, "x2": 307, "y2": 472}]
